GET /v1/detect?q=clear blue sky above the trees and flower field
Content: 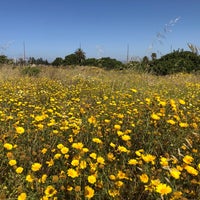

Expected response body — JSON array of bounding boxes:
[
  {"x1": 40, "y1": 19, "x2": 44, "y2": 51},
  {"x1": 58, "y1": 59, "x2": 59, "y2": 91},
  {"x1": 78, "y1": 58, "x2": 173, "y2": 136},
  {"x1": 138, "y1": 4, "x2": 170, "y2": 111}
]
[{"x1": 0, "y1": 0, "x2": 200, "y2": 61}]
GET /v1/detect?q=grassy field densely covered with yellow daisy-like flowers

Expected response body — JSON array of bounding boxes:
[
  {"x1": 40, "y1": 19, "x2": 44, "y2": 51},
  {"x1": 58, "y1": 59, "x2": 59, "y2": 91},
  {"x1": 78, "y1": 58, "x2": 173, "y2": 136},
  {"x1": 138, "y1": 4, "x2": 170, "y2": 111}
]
[{"x1": 0, "y1": 68, "x2": 200, "y2": 200}]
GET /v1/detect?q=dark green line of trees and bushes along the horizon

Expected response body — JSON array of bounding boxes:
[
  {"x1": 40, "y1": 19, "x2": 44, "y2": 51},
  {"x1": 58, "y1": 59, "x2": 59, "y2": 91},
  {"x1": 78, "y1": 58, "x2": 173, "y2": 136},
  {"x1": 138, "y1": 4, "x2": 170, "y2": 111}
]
[{"x1": 0, "y1": 48, "x2": 200, "y2": 75}]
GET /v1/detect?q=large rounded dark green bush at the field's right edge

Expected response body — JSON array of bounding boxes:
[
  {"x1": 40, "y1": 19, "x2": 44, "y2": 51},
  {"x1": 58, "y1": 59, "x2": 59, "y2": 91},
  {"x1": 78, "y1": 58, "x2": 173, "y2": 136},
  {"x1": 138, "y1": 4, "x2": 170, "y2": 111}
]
[{"x1": 148, "y1": 50, "x2": 200, "y2": 75}]
